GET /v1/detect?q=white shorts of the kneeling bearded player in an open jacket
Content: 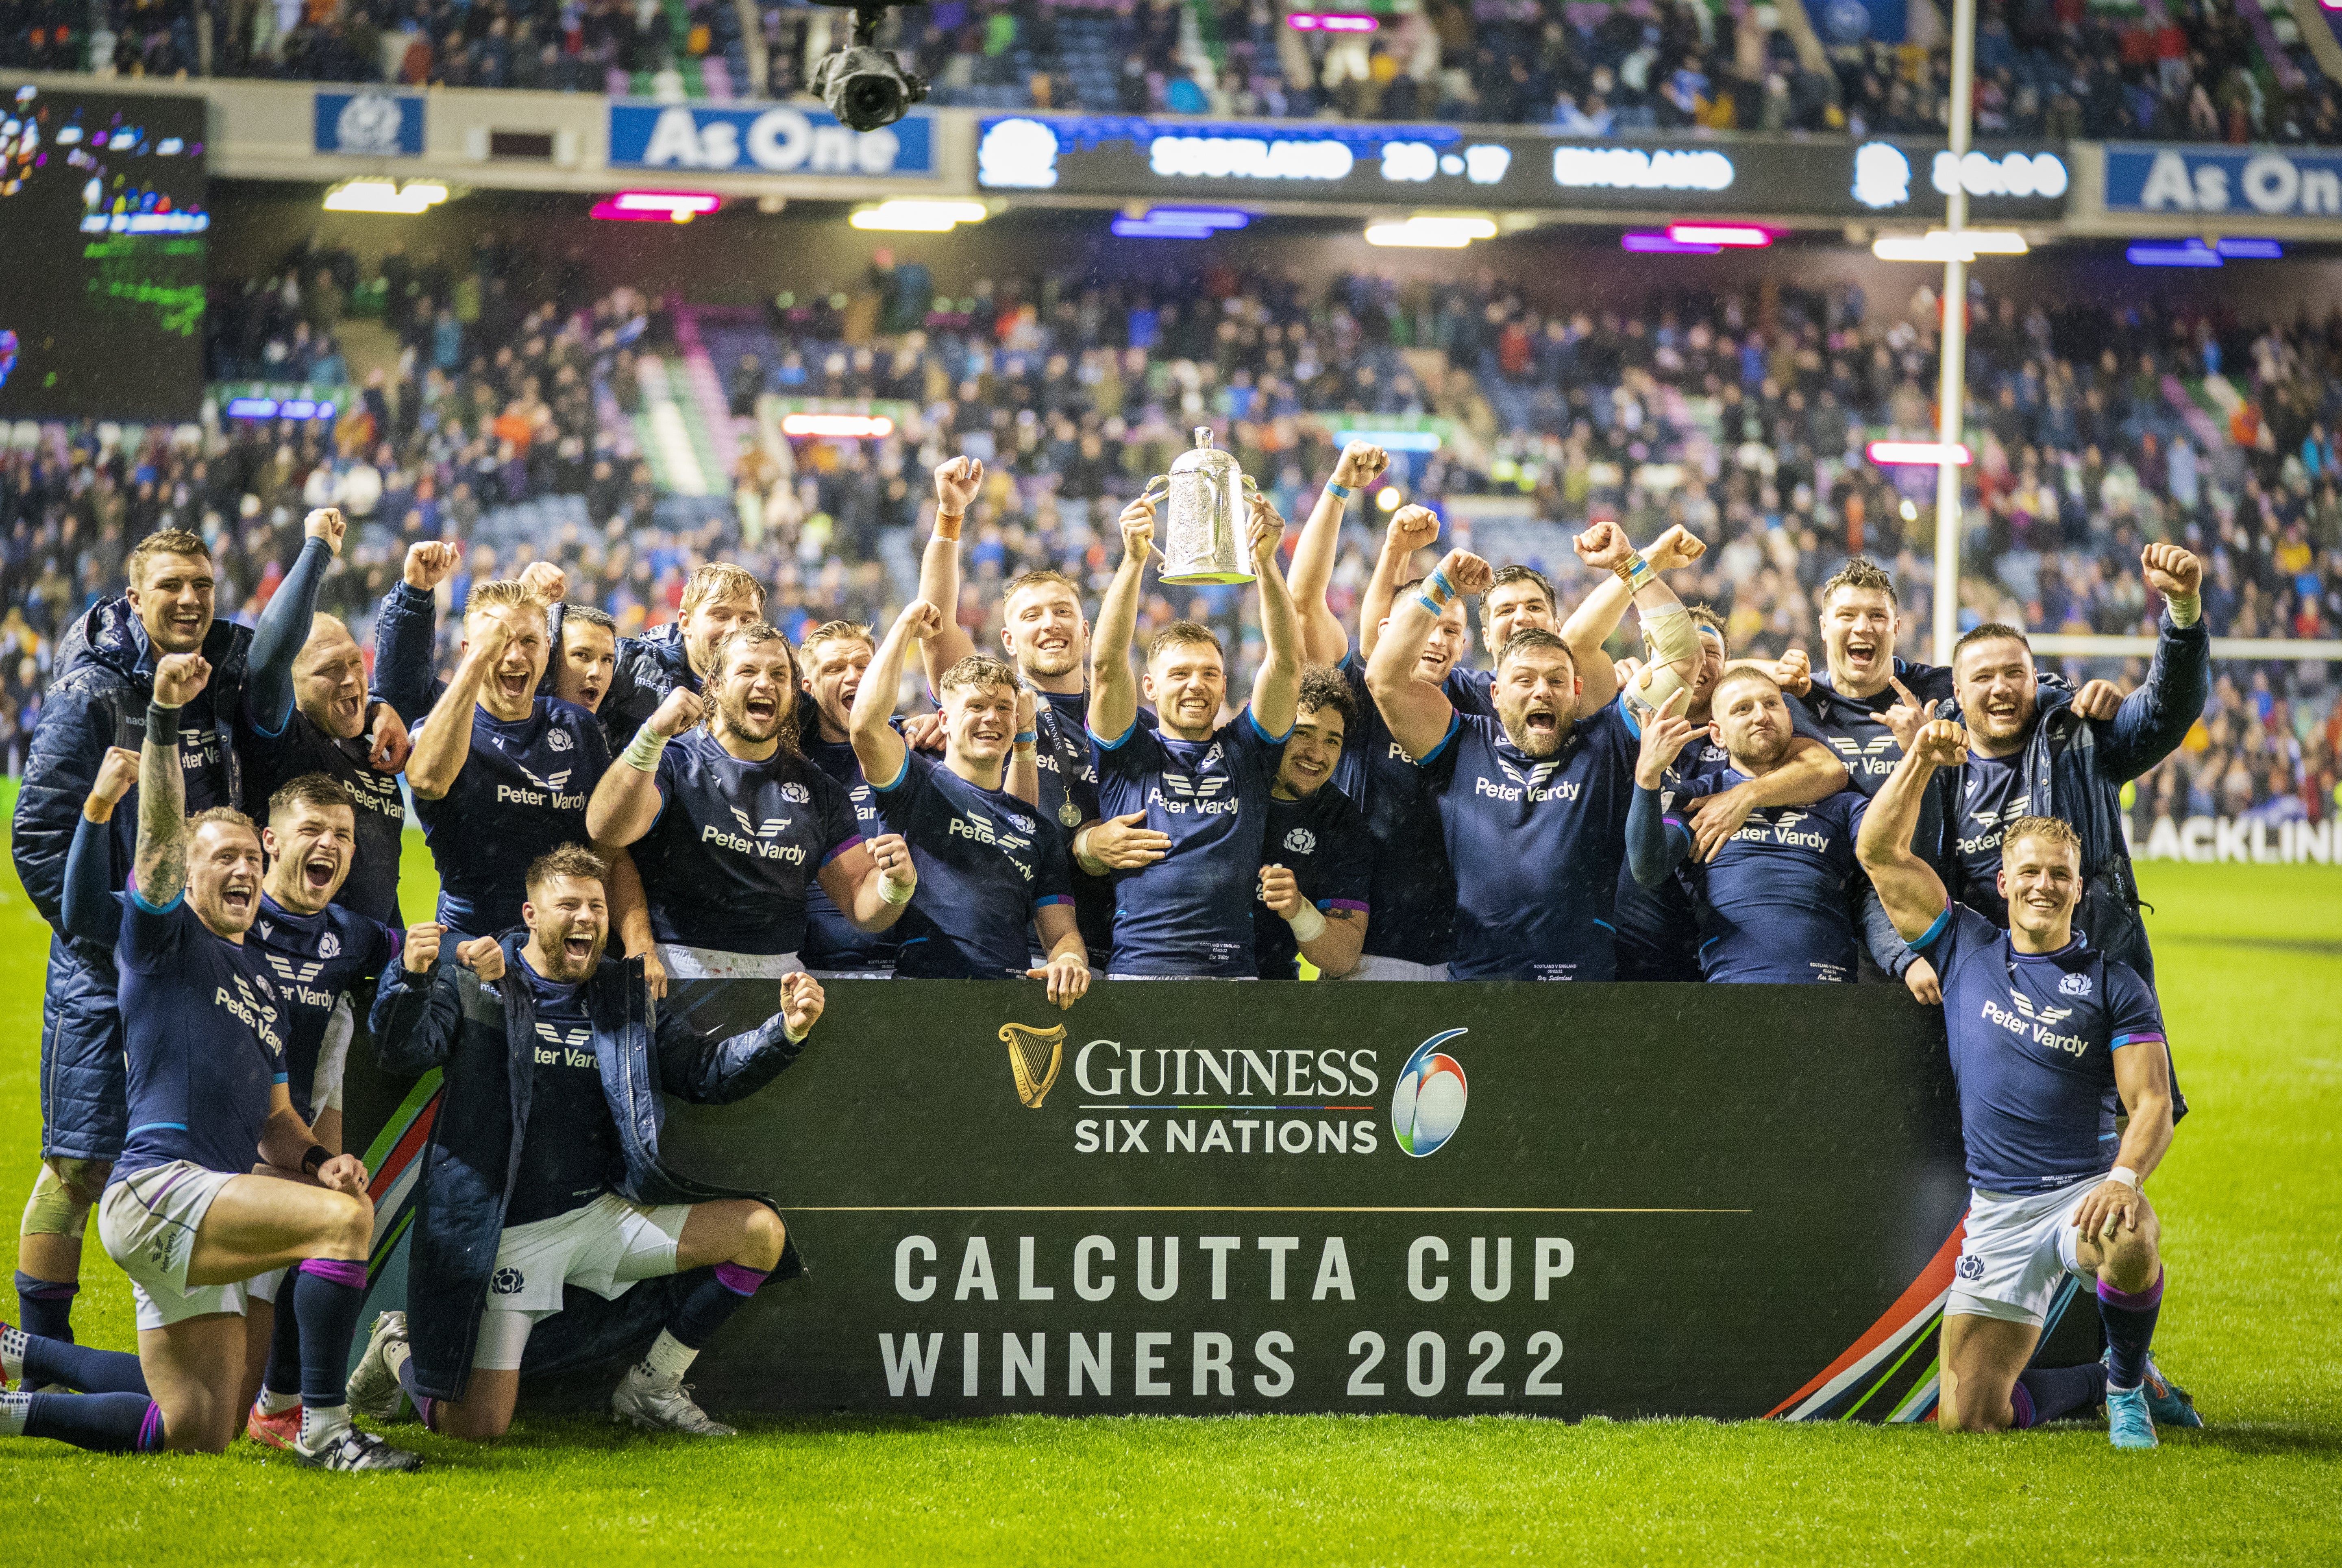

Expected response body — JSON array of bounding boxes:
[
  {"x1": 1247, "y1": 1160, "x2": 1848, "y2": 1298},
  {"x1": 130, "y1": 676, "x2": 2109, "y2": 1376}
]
[{"x1": 471, "y1": 1193, "x2": 691, "y2": 1371}]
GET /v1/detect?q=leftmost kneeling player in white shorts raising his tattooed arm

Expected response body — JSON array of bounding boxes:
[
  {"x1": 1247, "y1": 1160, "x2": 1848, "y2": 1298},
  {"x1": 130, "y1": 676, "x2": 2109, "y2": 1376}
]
[{"x1": 0, "y1": 654, "x2": 419, "y2": 1470}]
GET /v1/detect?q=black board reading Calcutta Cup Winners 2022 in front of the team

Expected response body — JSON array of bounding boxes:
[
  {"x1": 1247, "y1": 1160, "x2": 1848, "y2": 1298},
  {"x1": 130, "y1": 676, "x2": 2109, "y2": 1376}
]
[{"x1": 349, "y1": 982, "x2": 2096, "y2": 1420}]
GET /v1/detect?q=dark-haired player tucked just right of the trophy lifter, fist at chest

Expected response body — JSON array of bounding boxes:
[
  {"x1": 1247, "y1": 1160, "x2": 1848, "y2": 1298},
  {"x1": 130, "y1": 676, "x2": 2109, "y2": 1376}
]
[{"x1": 1253, "y1": 666, "x2": 1375, "y2": 980}]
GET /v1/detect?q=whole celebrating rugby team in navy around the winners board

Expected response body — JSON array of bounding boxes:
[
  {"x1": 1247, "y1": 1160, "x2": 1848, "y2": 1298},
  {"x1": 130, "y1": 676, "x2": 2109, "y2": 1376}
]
[{"x1": 0, "y1": 445, "x2": 2209, "y2": 1470}]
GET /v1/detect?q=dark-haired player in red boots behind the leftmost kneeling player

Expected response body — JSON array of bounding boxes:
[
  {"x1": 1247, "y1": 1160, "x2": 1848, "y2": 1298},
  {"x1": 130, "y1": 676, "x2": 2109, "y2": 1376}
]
[{"x1": 65, "y1": 748, "x2": 400, "y2": 1448}]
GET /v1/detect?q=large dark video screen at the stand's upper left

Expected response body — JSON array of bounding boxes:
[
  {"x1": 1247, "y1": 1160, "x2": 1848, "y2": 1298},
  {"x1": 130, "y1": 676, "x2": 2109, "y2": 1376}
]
[{"x1": 0, "y1": 87, "x2": 211, "y2": 420}]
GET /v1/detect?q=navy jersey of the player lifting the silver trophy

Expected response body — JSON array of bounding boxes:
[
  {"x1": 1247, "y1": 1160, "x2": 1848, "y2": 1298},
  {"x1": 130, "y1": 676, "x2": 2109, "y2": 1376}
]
[{"x1": 1089, "y1": 708, "x2": 1293, "y2": 980}]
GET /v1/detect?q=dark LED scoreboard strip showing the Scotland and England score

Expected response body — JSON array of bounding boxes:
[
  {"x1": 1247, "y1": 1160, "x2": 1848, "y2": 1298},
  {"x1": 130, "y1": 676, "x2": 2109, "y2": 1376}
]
[{"x1": 977, "y1": 115, "x2": 2070, "y2": 223}]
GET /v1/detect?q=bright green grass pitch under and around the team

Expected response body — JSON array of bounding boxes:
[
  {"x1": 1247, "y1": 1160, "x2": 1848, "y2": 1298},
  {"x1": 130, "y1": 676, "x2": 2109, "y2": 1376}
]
[{"x1": 0, "y1": 825, "x2": 2342, "y2": 1566}]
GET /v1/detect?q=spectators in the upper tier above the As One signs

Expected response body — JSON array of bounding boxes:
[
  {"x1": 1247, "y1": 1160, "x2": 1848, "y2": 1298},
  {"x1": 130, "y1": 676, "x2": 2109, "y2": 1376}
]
[{"x1": 23, "y1": 0, "x2": 2342, "y2": 145}]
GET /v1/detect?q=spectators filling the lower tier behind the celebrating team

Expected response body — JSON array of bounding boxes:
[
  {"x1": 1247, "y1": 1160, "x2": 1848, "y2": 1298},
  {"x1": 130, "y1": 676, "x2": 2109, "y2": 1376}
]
[{"x1": 0, "y1": 237, "x2": 2342, "y2": 816}]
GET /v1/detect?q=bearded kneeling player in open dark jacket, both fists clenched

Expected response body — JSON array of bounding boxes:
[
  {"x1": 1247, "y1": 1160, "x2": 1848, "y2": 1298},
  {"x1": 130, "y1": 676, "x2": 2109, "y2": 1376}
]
[{"x1": 351, "y1": 844, "x2": 822, "y2": 1442}]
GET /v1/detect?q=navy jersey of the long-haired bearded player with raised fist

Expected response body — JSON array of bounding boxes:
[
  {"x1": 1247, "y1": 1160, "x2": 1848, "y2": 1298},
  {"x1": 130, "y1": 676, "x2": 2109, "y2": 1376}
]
[{"x1": 632, "y1": 727, "x2": 862, "y2": 956}]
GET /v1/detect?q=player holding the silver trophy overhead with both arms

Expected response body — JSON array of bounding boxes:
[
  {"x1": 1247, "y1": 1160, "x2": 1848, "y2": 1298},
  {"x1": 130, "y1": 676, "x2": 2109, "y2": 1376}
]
[{"x1": 1084, "y1": 494, "x2": 1302, "y2": 980}]
